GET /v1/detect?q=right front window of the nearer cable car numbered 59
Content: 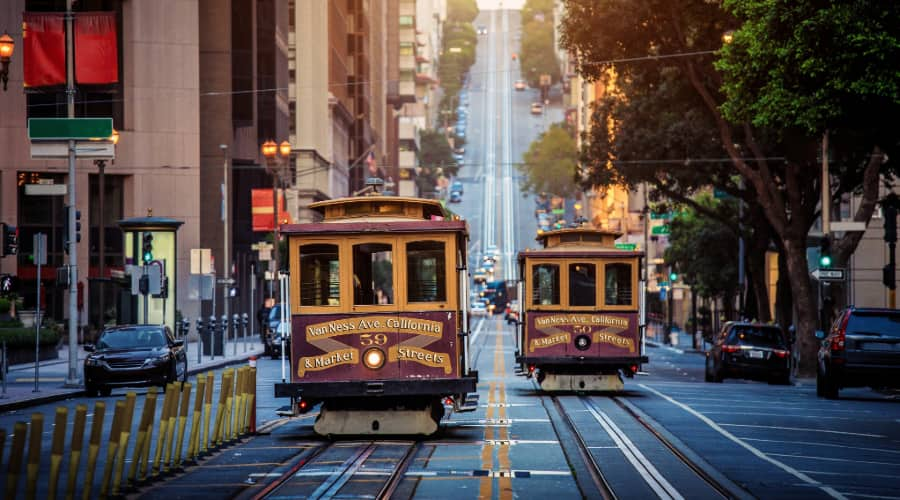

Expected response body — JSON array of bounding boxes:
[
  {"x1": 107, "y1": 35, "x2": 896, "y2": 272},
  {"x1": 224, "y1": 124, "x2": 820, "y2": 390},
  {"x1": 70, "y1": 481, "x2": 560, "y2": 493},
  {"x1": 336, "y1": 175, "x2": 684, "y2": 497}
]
[{"x1": 406, "y1": 241, "x2": 447, "y2": 302}]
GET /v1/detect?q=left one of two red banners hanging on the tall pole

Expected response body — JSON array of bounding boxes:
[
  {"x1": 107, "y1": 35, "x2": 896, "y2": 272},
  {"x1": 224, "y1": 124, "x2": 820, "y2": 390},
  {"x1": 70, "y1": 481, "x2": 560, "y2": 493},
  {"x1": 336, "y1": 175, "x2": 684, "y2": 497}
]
[{"x1": 22, "y1": 12, "x2": 66, "y2": 87}]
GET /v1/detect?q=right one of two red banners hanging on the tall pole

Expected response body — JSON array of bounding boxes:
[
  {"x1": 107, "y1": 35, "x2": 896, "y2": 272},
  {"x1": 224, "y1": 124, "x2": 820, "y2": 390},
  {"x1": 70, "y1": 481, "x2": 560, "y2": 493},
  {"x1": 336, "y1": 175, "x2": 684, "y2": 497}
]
[{"x1": 75, "y1": 12, "x2": 119, "y2": 85}]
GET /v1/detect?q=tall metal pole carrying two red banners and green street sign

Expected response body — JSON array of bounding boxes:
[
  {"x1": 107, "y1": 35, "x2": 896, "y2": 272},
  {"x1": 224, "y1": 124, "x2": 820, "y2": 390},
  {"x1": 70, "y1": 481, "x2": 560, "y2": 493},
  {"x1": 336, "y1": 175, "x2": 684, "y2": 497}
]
[{"x1": 66, "y1": 0, "x2": 81, "y2": 386}]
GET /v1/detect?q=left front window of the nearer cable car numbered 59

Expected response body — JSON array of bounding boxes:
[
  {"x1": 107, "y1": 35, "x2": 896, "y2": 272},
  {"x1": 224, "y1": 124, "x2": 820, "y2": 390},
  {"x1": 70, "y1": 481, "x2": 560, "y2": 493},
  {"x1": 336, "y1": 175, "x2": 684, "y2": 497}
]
[{"x1": 300, "y1": 244, "x2": 341, "y2": 306}]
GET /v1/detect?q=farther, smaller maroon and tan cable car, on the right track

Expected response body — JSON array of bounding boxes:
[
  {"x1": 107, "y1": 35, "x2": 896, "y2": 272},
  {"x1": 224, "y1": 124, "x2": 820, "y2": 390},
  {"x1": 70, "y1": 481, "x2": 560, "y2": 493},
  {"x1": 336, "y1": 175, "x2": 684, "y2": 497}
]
[{"x1": 516, "y1": 228, "x2": 647, "y2": 391}]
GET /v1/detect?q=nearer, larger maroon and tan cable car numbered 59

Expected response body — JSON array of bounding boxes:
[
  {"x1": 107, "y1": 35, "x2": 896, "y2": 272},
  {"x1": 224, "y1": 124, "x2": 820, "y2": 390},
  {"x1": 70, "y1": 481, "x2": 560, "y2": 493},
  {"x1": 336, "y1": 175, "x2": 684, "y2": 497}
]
[{"x1": 275, "y1": 196, "x2": 477, "y2": 435}]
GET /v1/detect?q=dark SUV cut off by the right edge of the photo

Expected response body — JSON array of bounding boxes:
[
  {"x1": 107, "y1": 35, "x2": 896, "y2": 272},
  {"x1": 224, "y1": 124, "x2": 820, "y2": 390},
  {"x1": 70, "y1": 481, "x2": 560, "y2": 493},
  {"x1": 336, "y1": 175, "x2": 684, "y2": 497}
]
[{"x1": 816, "y1": 306, "x2": 900, "y2": 399}]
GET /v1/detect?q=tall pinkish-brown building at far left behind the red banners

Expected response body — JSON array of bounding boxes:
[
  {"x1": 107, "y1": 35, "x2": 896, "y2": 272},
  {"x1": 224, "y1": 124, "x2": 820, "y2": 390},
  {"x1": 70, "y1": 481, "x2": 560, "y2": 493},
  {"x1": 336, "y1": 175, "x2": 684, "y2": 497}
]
[{"x1": 0, "y1": 0, "x2": 288, "y2": 332}]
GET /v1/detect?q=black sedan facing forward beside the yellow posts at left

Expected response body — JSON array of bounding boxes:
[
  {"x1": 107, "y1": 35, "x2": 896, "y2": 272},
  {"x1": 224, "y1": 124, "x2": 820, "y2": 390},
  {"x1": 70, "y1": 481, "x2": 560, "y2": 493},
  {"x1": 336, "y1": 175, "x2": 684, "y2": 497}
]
[{"x1": 84, "y1": 325, "x2": 187, "y2": 396}]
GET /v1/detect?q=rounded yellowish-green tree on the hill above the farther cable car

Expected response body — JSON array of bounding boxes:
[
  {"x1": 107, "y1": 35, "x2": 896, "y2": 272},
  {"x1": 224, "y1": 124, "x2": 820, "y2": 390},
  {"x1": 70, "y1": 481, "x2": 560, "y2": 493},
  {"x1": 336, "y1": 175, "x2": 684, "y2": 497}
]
[{"x1": 518, "y1": 123, "x2": 579, "y2": 198}]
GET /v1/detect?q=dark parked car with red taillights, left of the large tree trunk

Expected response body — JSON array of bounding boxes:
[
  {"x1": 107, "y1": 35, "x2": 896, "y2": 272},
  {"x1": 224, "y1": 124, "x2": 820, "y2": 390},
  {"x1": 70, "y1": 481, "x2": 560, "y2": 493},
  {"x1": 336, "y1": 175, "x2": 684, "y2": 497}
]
[{"x1": 705, "y1": 322, "x2": 791, "y2": 384}]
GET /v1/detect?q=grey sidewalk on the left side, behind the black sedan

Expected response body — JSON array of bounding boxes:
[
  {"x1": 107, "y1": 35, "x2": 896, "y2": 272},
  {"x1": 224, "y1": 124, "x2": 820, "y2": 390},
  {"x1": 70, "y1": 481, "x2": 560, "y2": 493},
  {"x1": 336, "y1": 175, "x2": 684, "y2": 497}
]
[{"x1": 0, "y1": 336, "x2": 263, "y2": 412}]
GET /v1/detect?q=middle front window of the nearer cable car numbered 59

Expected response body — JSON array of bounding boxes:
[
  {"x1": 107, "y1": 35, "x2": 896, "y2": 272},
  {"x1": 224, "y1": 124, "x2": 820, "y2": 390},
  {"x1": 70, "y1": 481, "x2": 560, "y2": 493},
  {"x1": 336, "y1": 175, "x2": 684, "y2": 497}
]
[{"x1": 353, "y1": 243, "x2": 394, "y2": 306}]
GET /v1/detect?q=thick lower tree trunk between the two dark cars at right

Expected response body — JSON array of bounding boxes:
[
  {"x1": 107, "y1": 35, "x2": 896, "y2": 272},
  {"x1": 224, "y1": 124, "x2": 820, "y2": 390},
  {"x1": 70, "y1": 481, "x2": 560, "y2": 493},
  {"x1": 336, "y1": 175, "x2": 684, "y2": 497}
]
[{"x1": 784, "y1": 237, "x2": 818, "y2": 377}]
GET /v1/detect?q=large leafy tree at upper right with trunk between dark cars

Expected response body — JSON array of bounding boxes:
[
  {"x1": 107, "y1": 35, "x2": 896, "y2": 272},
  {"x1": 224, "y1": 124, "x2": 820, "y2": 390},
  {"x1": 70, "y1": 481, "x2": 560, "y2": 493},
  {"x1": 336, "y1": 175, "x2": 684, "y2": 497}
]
[{"x1": 562, "y1": 0, "x2": 898, "y2": 374}]
